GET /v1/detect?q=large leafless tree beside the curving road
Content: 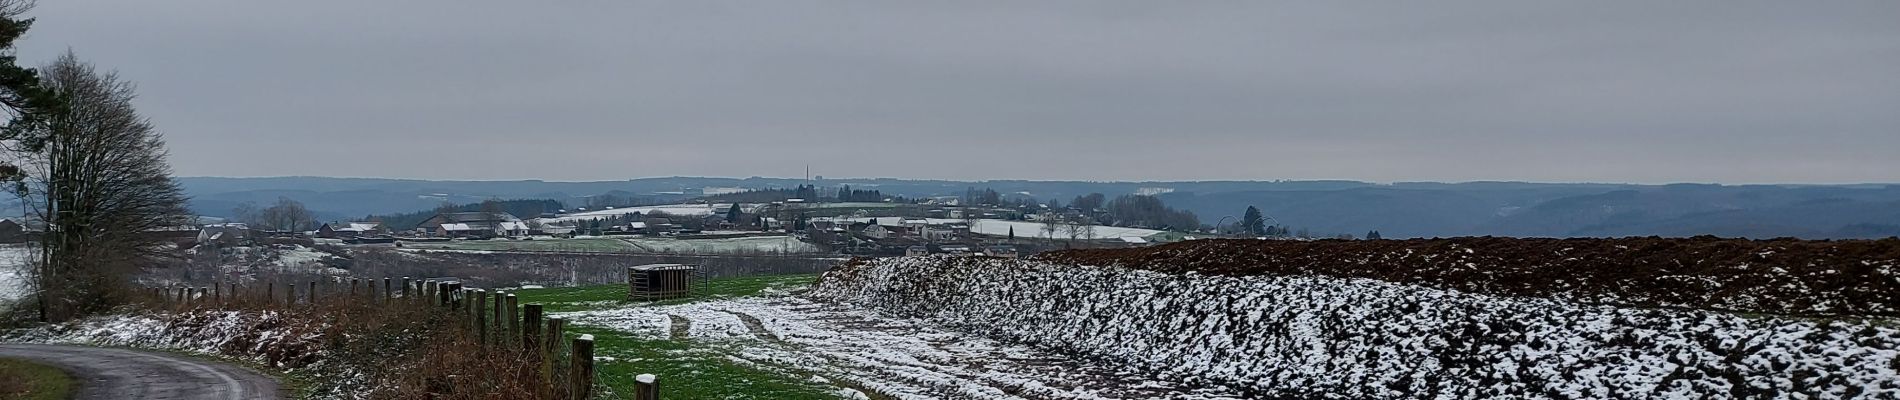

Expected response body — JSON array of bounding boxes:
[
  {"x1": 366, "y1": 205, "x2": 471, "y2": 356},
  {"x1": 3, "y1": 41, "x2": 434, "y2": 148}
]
[{"x1": 17, "y1": 53, "x2": 186, "y2": 320}]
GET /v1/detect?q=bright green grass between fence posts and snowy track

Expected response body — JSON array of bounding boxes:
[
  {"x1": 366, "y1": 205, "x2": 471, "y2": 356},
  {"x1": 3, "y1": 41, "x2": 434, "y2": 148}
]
[{"x1": 515, "y1": 275, "x2": 840, "y2": 400}]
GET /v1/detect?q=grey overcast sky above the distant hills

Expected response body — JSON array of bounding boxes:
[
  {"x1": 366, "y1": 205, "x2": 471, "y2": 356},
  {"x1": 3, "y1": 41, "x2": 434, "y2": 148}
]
[{"x1": 19, "y1": 0, "x2": 1900, "y2": 184}]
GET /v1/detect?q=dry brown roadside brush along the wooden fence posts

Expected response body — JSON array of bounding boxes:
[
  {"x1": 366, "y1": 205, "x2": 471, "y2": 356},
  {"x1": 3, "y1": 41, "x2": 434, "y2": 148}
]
[{"x1": 136, "y1": 286, "x2": 581, "y2": 398}]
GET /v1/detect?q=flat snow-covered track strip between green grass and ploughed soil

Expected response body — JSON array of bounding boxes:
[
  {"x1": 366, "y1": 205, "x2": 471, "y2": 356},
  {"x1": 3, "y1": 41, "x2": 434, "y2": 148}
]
[{"x1": 553, "y1": 296, "x2": 1241, "y2": 400}]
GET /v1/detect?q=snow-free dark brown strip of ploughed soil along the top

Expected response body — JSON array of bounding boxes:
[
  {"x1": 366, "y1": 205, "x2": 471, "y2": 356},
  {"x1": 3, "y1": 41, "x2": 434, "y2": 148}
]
[{"x1": 1037, "y1": 237, "x2": 1900, "y2": 317}]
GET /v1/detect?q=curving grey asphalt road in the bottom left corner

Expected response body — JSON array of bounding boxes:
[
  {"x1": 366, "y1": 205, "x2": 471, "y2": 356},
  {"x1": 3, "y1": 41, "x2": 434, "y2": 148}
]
[{"x1": 0, "y1": 345, "x2": 283, "y2": 400}]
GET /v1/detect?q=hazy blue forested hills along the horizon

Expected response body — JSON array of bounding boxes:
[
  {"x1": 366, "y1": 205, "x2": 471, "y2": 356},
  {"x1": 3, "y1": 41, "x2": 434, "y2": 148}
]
[{"x1": 181, "y1": 176, "x2": 1900, "y2": 239}]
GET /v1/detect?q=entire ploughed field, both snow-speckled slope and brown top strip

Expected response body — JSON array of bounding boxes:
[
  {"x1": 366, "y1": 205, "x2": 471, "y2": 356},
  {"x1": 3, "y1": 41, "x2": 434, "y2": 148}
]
[{"x1": 820, "y1": 237, "x2": 1900, "y2": 398}]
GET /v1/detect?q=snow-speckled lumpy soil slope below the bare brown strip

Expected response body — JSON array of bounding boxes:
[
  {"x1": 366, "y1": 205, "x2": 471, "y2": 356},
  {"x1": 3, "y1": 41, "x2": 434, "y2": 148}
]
[{"x1": 809, "y1": 258, "x2": 1900, "y2": 398}]
